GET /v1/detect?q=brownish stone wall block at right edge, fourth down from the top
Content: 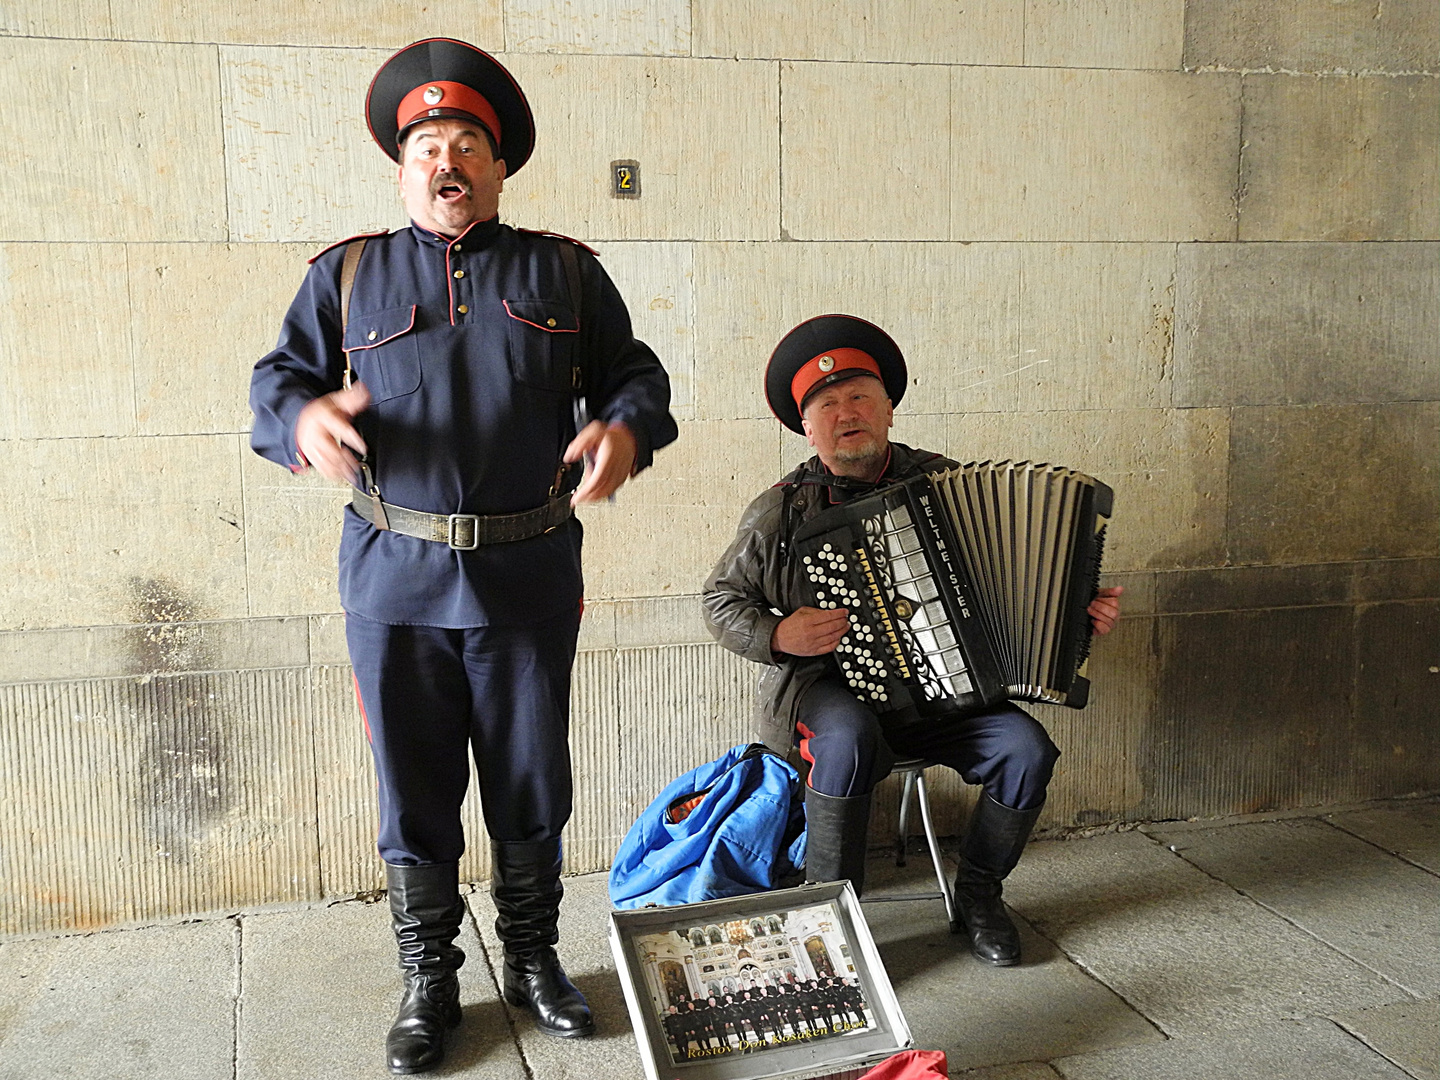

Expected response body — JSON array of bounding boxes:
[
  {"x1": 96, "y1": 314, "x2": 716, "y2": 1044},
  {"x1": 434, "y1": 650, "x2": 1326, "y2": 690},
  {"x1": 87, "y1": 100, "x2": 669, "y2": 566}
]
[{"x1": 1225, "y1": 402, "x2": 1440, "y2": 564}]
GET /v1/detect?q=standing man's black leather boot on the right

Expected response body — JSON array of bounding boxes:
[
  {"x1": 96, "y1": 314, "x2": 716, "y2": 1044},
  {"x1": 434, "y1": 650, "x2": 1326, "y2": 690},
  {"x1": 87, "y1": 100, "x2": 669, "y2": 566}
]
[{"x1": 490, "y1": 840, "x2": 595, "y2": 1038}]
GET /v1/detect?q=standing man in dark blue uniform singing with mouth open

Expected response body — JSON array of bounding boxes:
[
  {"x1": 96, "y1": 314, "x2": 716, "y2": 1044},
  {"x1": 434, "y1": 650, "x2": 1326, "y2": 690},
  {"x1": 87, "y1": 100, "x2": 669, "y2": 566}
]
[{"x1": 251, "y1": 39, "x2": 677, "y2": 1073}]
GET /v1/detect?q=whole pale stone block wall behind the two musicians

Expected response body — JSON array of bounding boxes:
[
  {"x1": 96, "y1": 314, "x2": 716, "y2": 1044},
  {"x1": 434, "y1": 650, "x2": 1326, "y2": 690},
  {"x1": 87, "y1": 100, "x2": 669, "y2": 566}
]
[{"x1": 0, "y1": 0, "x2": 1440, "y2": 935}]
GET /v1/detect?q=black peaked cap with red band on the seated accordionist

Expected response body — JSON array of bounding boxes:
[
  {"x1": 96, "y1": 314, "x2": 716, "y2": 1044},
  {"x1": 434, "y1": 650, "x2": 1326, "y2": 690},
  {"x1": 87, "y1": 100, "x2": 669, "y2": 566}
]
[{"x1": 765, "y1": 315, "x2": 909, "y2": 433}]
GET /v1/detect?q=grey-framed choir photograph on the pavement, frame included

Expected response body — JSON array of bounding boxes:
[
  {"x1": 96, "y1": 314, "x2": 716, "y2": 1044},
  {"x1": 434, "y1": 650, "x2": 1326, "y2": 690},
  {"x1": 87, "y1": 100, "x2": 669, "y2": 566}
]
[{"x1": 611, "y1": 881, "x2": 912, "y2": 1080}]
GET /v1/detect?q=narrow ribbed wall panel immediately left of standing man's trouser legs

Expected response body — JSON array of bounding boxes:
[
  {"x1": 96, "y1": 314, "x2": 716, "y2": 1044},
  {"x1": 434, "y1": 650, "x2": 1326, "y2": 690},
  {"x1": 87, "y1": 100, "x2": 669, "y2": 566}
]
[{"x1": 310, "y1": 665, "x2": 384, "y2": 896}]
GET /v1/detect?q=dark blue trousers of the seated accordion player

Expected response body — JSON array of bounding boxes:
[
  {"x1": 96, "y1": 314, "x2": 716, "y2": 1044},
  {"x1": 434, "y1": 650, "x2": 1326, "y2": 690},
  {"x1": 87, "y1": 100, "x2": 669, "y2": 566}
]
[{"x1": 796, "y1": 675, "x2": 1060, "y2": 809}]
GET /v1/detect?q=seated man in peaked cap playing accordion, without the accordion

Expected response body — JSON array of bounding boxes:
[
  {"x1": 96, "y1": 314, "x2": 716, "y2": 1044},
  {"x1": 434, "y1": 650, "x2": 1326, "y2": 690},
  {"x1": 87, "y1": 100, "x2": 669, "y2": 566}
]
[{"x1": 701, "y1": 315, "x2": 1120, "y2": 966}]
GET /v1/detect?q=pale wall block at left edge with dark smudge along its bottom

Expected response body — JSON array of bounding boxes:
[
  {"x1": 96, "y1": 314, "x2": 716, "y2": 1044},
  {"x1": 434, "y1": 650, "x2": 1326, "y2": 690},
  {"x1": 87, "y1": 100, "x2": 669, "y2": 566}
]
[{"x1": 0, "y1": 435, "x2": 245, "y2": 629}]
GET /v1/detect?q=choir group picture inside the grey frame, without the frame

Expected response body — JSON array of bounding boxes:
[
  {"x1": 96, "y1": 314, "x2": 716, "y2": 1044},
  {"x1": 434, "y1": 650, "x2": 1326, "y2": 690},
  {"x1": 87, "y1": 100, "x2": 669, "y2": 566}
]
[{"x1": 635, "y1": 903, "x2": 876, "y2": 1064}]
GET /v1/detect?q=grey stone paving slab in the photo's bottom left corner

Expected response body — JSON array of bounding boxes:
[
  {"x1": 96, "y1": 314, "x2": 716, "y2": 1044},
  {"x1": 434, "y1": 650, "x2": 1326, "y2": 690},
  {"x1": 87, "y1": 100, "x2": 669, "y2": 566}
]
[{"x1": 0, "y1": 919, "x2": 238, "y2": 1080}]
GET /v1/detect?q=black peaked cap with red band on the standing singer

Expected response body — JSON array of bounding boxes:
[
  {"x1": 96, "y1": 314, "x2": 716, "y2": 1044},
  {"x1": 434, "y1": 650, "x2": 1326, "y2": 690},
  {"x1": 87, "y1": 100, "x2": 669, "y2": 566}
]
[{"x1": 364, "y1": 37, "x2": 536, "y2": 176}]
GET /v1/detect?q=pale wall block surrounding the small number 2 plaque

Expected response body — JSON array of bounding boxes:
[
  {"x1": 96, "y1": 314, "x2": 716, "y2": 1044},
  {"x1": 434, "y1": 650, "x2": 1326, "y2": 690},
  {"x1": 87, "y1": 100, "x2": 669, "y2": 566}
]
[{"x1": 501, "y1": 53, "x2": 779, "y2": 240}]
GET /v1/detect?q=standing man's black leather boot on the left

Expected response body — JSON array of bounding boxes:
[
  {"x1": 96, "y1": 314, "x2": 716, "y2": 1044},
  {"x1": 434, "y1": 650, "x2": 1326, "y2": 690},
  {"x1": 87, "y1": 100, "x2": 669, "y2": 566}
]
[{"x1": 384, "y1": 863, "x2": 465, "y2": 1074}]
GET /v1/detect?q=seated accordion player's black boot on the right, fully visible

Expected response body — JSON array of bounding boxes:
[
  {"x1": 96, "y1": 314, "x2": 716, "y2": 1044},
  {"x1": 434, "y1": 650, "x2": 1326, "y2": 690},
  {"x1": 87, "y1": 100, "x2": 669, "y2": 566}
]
[{"x1": 950, "y1": 792, "x2": 1041, "y2": 968}]
